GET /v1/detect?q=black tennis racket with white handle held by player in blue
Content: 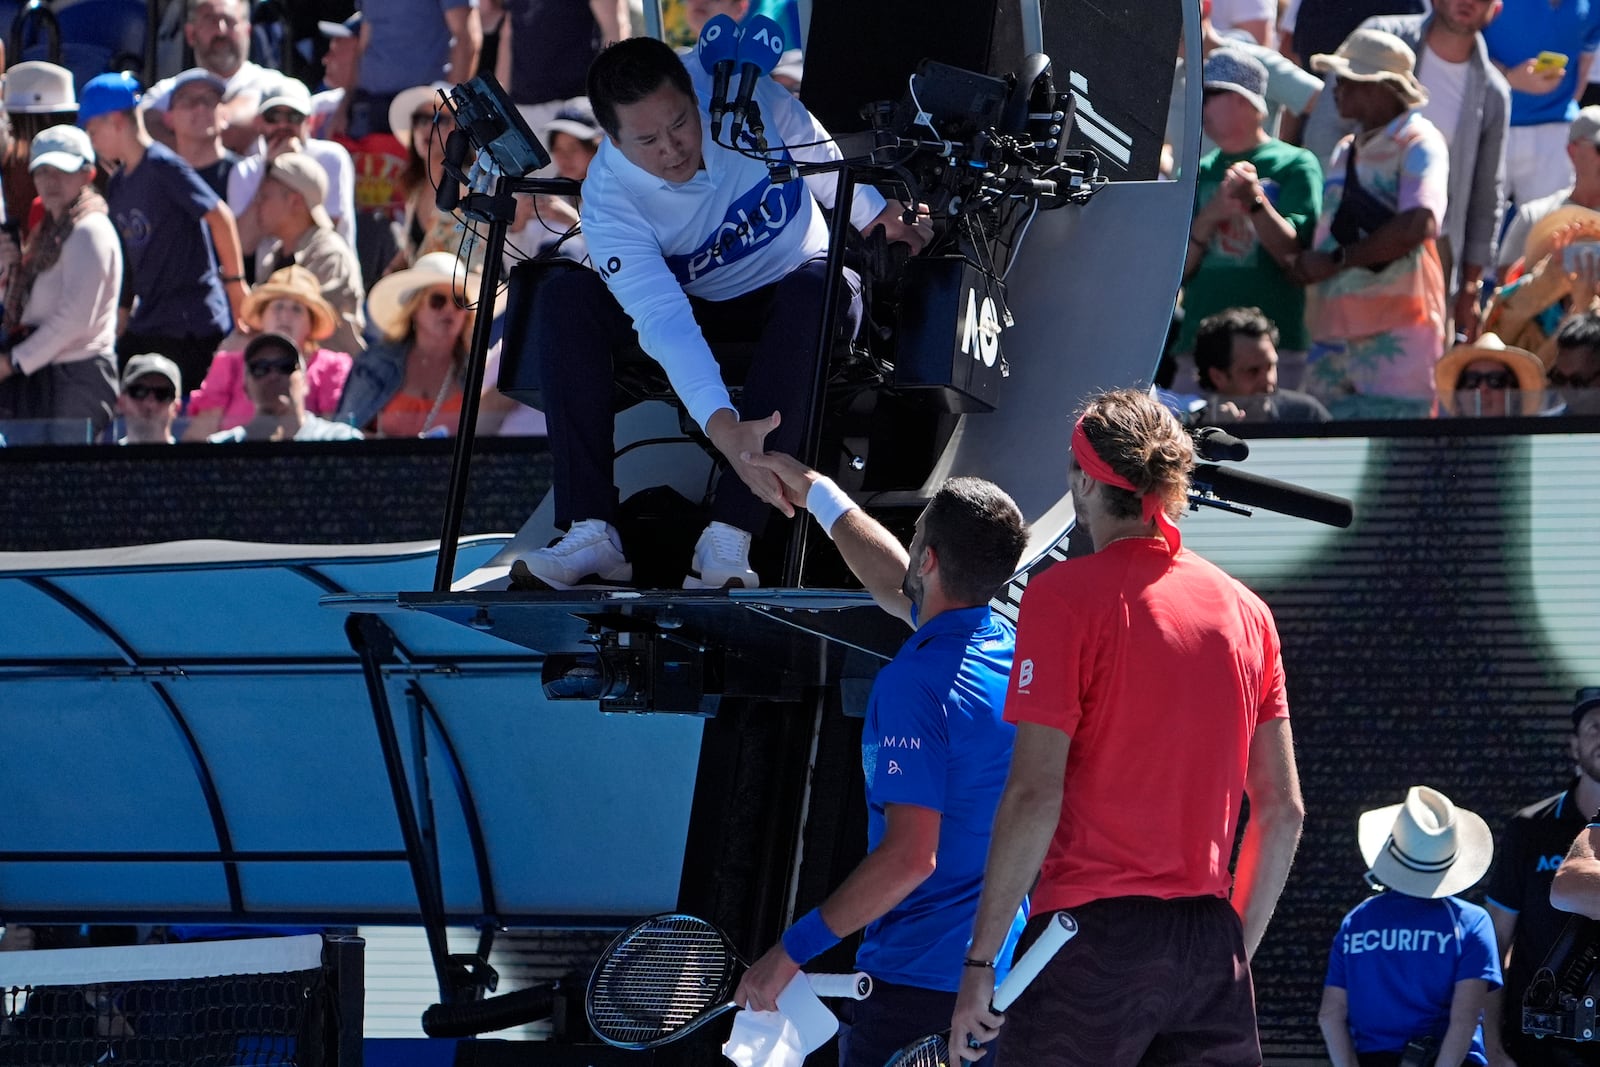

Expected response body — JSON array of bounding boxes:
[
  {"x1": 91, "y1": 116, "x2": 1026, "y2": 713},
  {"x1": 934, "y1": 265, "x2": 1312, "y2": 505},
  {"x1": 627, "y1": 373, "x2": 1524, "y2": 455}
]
[{"x1": 584, "y1": 913, "x2": 872, "y2": 1049}]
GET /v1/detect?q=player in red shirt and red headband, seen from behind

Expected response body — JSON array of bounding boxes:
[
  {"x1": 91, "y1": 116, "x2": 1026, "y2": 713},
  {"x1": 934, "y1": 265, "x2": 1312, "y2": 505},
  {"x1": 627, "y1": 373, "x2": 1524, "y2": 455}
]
[{"x1": 950, "y1": 390, "x2": 1304, "y2": 1067}]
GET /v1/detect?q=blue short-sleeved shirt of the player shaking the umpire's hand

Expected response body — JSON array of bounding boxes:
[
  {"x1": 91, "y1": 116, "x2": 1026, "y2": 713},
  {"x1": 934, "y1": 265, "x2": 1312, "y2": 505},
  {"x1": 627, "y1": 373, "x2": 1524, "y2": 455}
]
[{"x1": 856, "y1": 605, "x2": 1016, "y2": 992}]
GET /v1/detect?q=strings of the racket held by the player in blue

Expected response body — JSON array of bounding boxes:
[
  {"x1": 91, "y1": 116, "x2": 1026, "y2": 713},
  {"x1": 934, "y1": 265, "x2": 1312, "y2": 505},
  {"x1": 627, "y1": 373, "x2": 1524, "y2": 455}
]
[{"x1": 589, "y1": 917, "x2": 733, "y2": 1045}]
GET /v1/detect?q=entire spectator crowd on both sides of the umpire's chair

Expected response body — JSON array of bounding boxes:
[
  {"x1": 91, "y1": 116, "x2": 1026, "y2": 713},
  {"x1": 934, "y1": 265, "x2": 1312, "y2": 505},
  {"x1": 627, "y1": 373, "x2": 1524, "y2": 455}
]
[{"x1": 0, "y1": 0, "x2": 1600, "y2": 442}]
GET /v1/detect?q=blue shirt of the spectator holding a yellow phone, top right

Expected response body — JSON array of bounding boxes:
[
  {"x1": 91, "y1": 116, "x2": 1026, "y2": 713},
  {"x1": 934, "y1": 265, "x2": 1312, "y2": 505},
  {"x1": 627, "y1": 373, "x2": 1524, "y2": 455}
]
[{"x1": 1483, "y1": 0, "x2": 1600, "y2": 126}]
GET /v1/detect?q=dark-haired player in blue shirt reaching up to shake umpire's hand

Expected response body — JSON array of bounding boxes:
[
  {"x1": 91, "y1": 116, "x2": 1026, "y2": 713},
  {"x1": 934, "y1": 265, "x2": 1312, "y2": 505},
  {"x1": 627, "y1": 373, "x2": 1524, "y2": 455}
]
[{"x1": 733, "y1": 453, "x2": 1027, "y2": 1067}]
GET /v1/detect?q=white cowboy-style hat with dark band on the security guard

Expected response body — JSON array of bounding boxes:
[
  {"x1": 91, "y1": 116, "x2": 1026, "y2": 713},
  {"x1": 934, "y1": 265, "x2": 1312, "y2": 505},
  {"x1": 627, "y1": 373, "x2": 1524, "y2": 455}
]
[{"x1": 1357, "y1": 785, "x2": 1494, "y2": 899}]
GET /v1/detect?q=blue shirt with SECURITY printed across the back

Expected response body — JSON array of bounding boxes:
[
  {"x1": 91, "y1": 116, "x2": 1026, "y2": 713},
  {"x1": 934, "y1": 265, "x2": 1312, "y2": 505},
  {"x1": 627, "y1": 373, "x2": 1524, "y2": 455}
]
[{"x1": 1326, "y1": 891, "x2": 1501, "y2": 1064}]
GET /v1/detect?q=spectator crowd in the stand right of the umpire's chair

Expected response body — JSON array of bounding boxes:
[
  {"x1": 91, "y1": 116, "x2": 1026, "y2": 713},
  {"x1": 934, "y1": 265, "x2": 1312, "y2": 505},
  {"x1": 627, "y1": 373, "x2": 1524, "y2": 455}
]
[{"x1": 1177, "y1": 0, "x2": 1600, "y2": 422}]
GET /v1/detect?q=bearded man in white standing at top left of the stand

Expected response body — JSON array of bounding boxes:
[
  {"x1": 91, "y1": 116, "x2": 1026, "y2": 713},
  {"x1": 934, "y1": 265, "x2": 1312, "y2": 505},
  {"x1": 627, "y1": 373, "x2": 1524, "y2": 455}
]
[{"x1": 142, "y1": 0, "x2": 280, "y2": 155}]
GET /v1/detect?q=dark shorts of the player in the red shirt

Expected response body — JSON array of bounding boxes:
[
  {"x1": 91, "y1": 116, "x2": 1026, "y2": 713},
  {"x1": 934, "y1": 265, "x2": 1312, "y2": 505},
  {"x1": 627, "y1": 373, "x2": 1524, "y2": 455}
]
[{"x1": 1000, "y1": 897, "x2": 1261, "y2": 1067}]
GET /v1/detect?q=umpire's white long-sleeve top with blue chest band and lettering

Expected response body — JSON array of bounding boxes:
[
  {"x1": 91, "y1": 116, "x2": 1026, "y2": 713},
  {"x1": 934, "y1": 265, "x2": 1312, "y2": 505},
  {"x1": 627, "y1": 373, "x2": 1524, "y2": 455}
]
[{"x1": 582, "y1": 62, "x2": 885, "y2": 429}]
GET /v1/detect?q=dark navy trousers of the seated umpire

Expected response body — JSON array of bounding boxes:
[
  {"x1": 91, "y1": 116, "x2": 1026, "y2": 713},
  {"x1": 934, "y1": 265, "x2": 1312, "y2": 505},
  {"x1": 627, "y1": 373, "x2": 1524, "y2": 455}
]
[{"x1": 528, "y1": 259, "x2": 861, "y2": 534}]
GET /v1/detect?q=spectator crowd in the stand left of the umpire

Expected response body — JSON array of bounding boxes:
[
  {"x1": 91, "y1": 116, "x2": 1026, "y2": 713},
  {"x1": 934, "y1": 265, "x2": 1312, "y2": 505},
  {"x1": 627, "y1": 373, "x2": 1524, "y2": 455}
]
[{"x1": 0, "y1": 0, "x2": 632, "y2": 443}]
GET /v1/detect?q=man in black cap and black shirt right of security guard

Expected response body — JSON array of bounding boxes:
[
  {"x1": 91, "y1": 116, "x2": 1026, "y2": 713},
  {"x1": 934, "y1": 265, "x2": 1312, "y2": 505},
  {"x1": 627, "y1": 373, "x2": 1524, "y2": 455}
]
[{"x1": 1483, "y1": 686, "x2": 1600, "y2": 1067}]
